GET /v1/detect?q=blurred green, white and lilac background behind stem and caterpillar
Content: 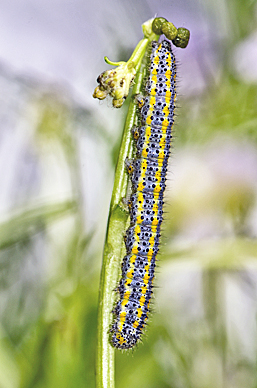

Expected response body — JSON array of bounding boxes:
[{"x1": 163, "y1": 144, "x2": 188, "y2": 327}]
[{"x1": 0, "y1": 0, "x2": 257, "y2": 388}]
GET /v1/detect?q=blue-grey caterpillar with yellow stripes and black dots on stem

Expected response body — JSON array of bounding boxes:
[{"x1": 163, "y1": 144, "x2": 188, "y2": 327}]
[{"x1": 111, "y1": 40, "x2": 176, "y2": 349}]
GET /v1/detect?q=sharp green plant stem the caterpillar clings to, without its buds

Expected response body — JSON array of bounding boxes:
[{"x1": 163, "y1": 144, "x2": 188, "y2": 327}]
[{"x1": 96, "y1": 35, "x2": 156, "y2": 388}]
